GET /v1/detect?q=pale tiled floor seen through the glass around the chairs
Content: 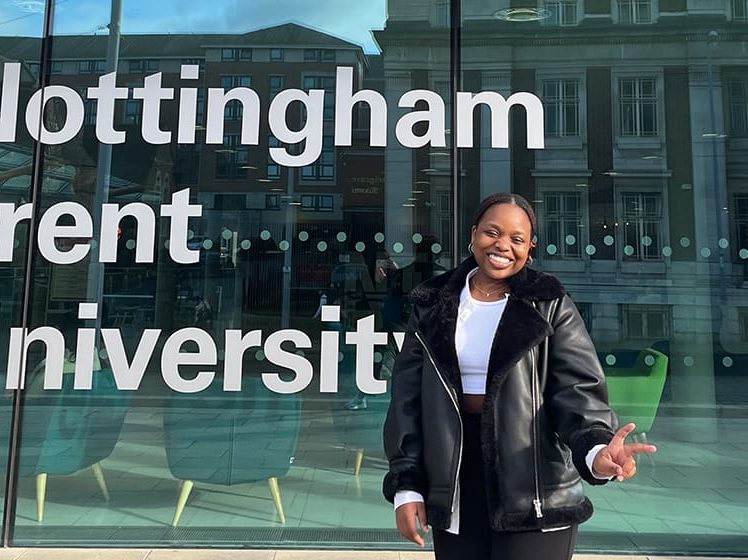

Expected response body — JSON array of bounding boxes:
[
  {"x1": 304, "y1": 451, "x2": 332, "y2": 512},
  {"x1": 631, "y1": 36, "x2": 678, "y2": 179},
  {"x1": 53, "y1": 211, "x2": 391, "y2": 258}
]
[{"x1": 5, "y1": 397, "x2": 748, "y2": 556}]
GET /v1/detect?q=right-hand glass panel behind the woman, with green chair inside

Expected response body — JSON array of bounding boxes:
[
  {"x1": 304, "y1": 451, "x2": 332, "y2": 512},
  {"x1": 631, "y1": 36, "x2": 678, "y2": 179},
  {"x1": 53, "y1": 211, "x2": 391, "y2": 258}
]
[{"x1": 458, "y1": 0, "x2": 748, "y2": 556}]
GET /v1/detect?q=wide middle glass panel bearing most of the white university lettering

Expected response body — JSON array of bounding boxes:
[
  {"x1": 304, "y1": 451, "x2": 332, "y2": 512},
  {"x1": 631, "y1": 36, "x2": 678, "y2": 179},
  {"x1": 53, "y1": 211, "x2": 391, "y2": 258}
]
[{"x1": 2, "y1": 0, "x2": 453, "y2": 548}]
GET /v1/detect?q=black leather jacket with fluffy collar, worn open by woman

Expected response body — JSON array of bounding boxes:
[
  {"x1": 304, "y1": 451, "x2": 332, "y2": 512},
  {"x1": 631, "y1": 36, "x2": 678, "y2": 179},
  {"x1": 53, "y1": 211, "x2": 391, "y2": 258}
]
[{"x1": 384, "y1": 257, "x2": 618, "y2": 531}]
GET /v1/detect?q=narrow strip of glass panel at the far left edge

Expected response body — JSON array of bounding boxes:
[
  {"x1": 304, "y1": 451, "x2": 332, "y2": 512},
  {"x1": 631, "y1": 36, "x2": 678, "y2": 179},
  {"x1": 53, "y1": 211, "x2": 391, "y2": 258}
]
[{"x1": 0, "y1": 2, "x2": 46, "y2": 544}]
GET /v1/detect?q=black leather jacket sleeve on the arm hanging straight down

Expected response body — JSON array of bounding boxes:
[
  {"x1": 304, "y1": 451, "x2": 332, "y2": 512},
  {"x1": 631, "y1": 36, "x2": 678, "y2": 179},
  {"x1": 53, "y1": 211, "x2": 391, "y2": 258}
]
[{"x1": 383, "y1": 307, "x2": 427, "y2": 502}]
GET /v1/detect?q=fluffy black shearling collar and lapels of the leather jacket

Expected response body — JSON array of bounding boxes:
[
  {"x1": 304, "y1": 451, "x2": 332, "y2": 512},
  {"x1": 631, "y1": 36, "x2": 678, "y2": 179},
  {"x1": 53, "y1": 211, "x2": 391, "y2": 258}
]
[{"x1": 409, "y1": 256, "x2": 565, "y2": 399}]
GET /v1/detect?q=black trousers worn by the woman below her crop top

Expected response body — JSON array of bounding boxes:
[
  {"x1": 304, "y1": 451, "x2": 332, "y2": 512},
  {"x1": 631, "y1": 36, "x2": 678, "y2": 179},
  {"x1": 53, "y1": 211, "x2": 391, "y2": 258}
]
[{"x1": 433, "y1": 413, "x2": 577, "y2": 560}]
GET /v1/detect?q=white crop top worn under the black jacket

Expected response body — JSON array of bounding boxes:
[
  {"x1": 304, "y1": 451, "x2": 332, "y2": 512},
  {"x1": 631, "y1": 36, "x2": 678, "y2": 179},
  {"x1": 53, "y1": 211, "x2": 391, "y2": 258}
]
[{"x1": 455, "y1": 268, "x2": 508, "y2": 395}]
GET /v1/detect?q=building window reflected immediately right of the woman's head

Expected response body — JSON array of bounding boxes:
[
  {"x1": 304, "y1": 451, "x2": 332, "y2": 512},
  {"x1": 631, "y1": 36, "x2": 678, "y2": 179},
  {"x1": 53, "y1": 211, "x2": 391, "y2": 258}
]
[{"x1": 543, "y1": 192, "x2": 582, "y2": 259}]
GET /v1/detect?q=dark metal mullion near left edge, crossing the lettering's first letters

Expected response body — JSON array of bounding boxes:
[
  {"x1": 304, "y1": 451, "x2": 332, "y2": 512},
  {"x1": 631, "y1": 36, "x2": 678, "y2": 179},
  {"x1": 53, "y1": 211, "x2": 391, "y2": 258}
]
[{"x1": 3, "y1": 0, "x2": 55, "y2": 547}]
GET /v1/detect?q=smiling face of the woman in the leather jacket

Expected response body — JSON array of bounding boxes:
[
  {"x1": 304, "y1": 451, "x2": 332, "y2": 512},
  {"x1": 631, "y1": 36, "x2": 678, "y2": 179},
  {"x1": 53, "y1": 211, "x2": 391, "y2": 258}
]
[{"x1": 470, "y1": 203, "x2": 535, "y2": 280}]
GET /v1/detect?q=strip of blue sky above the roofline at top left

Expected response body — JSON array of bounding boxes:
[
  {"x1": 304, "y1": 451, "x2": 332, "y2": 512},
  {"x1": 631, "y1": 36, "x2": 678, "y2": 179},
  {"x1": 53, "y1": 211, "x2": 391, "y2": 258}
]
[{"x1": 0, "y1": 0, "x2": 386, "y2": 54}]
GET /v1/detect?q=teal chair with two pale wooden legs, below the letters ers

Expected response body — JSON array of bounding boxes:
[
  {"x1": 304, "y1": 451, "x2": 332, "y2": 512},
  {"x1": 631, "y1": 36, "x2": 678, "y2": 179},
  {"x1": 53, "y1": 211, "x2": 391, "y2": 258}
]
[{"x1": 164, "y1": 377, "x2": 300, "y2": 527}]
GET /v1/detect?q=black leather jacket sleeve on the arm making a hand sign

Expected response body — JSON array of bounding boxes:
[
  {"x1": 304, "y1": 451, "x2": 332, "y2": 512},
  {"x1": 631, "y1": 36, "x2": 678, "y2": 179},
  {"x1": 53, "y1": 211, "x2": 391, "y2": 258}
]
[{"x1": 545, "y1": 296, "x2": 618, "y2": 484}]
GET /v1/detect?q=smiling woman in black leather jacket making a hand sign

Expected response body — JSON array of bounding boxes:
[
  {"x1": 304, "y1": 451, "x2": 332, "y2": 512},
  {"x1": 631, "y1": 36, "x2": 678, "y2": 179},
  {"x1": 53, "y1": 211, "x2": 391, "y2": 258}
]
[{"x1": 384, "y1": 193, "x2": 655, "y2": 560}]
